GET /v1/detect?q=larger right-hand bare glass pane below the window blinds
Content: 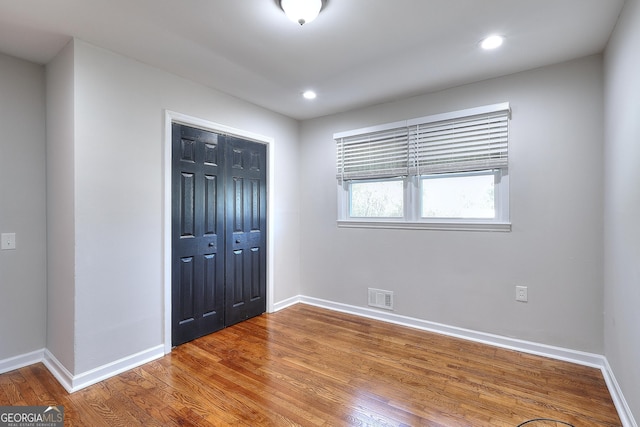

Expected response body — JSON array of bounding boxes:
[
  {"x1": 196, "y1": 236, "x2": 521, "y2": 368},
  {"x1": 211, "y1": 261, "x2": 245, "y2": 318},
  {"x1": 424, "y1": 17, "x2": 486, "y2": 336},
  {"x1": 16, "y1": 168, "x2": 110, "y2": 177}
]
[{"x1": 420, "y1": 171, "x2": 496, "y2": 219}]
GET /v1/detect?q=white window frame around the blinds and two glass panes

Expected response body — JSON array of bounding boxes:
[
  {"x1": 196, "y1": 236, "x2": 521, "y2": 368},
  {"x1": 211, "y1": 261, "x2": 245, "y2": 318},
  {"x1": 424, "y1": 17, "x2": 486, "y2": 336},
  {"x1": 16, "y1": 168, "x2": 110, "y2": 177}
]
[{"x1": 334, "y1": 103, "x2": 511, "y2": 232}]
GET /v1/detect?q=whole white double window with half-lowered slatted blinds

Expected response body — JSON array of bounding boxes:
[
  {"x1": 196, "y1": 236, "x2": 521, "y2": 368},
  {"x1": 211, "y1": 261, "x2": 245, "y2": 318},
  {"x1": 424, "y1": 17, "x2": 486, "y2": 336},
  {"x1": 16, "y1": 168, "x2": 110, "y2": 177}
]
[{"x1": 334, "y1": 103, "x2": 510, "y2": 231}]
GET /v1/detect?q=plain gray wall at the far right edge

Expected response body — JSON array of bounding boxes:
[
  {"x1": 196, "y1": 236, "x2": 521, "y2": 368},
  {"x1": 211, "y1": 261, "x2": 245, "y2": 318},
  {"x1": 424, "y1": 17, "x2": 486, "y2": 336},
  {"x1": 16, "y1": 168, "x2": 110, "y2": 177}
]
[{"x1": 604, "y1": 0, "x2": 640, "y2": 420}]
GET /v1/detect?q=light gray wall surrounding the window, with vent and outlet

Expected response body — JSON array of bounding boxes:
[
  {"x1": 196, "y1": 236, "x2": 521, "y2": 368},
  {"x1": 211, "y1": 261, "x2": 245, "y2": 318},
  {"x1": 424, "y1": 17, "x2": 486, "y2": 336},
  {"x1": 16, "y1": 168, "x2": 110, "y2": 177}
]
[{"x1": 301, "y1": 56, "x2": 603, "y2": 353}]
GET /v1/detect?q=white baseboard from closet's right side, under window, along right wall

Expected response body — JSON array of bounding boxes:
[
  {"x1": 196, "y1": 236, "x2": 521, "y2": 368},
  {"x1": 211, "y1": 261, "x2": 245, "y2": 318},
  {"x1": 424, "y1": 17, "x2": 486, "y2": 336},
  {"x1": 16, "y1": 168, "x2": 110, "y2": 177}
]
[{"x1": 294, "y1": 295, "x2": 638, "y2": 427}]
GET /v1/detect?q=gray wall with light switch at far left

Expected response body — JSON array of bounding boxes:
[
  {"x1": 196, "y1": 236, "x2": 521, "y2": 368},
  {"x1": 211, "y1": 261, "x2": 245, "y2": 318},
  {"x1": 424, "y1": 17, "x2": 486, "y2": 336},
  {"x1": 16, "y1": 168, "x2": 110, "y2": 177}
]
[{"x1": 0, "y1": 54, "x2": 47, "y2": 360}]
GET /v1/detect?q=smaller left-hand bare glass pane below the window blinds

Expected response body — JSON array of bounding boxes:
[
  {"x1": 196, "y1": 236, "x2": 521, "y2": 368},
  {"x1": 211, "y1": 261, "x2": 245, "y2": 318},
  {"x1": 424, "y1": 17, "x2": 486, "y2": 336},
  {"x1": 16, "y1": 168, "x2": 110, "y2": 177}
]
[{"x1": 349, "y1": 180, "x2": 404, "y2": 218}]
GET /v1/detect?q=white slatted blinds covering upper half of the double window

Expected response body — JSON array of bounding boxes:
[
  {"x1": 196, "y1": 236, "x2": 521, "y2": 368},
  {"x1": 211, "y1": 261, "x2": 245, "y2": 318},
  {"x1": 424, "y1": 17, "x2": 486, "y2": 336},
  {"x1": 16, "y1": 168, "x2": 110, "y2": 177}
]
[{"x1": 334, "y1": 103, "x2": 510, "y2": 181}]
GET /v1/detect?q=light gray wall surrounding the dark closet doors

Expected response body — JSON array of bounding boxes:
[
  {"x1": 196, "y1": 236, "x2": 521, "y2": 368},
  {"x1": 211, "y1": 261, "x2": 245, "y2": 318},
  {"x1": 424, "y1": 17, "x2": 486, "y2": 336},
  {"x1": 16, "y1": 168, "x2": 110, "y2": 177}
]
[{"x1": 48, "y1": 40, "x2": 300, "y2": 375}]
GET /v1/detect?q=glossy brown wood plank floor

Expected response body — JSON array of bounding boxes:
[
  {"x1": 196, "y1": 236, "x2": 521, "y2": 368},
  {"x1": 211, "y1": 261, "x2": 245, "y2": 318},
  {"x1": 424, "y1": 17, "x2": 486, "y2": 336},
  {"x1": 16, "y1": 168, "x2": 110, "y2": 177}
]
[{"x1": 0, "y1": 304, "x2": 621, "y2": 427}]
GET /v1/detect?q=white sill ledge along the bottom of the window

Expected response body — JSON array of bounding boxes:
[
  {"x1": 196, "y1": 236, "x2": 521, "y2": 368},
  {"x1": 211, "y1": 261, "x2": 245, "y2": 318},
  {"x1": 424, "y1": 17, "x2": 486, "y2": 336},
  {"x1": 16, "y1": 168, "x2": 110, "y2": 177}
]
[{"x1": 338, "y1": 220, "x2": 511, "y2": 232}]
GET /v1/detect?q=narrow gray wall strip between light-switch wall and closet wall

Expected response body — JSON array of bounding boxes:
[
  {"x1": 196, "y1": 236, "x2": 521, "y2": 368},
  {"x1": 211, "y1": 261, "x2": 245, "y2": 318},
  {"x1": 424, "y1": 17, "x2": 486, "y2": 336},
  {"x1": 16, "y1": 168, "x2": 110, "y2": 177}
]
[{"x1": 46, "y1": 42, "x2": 76, "y2": 372}]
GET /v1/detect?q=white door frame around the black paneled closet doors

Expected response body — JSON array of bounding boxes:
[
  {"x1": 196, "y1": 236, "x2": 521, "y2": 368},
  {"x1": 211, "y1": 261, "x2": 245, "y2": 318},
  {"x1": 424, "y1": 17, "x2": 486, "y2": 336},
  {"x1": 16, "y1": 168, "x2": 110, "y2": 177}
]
[{"x1": 162, "y1": 110, "x2": 275, "y2": 354}]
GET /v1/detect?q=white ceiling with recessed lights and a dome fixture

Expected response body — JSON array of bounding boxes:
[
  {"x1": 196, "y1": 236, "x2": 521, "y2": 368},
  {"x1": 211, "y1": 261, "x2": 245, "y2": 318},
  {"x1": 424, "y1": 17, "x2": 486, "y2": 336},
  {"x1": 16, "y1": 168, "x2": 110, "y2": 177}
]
[{"x1": 0, "y1": 0, "x2": 624, "y2": 120}]
